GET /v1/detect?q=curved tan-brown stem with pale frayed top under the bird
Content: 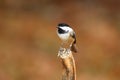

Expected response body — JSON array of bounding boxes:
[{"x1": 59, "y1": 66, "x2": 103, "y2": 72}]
[{"x1": 58, "y1": 48, "x2": 76, "y2": 80}]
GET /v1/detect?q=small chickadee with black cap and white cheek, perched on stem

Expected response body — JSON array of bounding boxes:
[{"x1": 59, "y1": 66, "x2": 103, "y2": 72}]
[{"x1": 57, "y1": 23, "x2": 77, "y2": 53}]
